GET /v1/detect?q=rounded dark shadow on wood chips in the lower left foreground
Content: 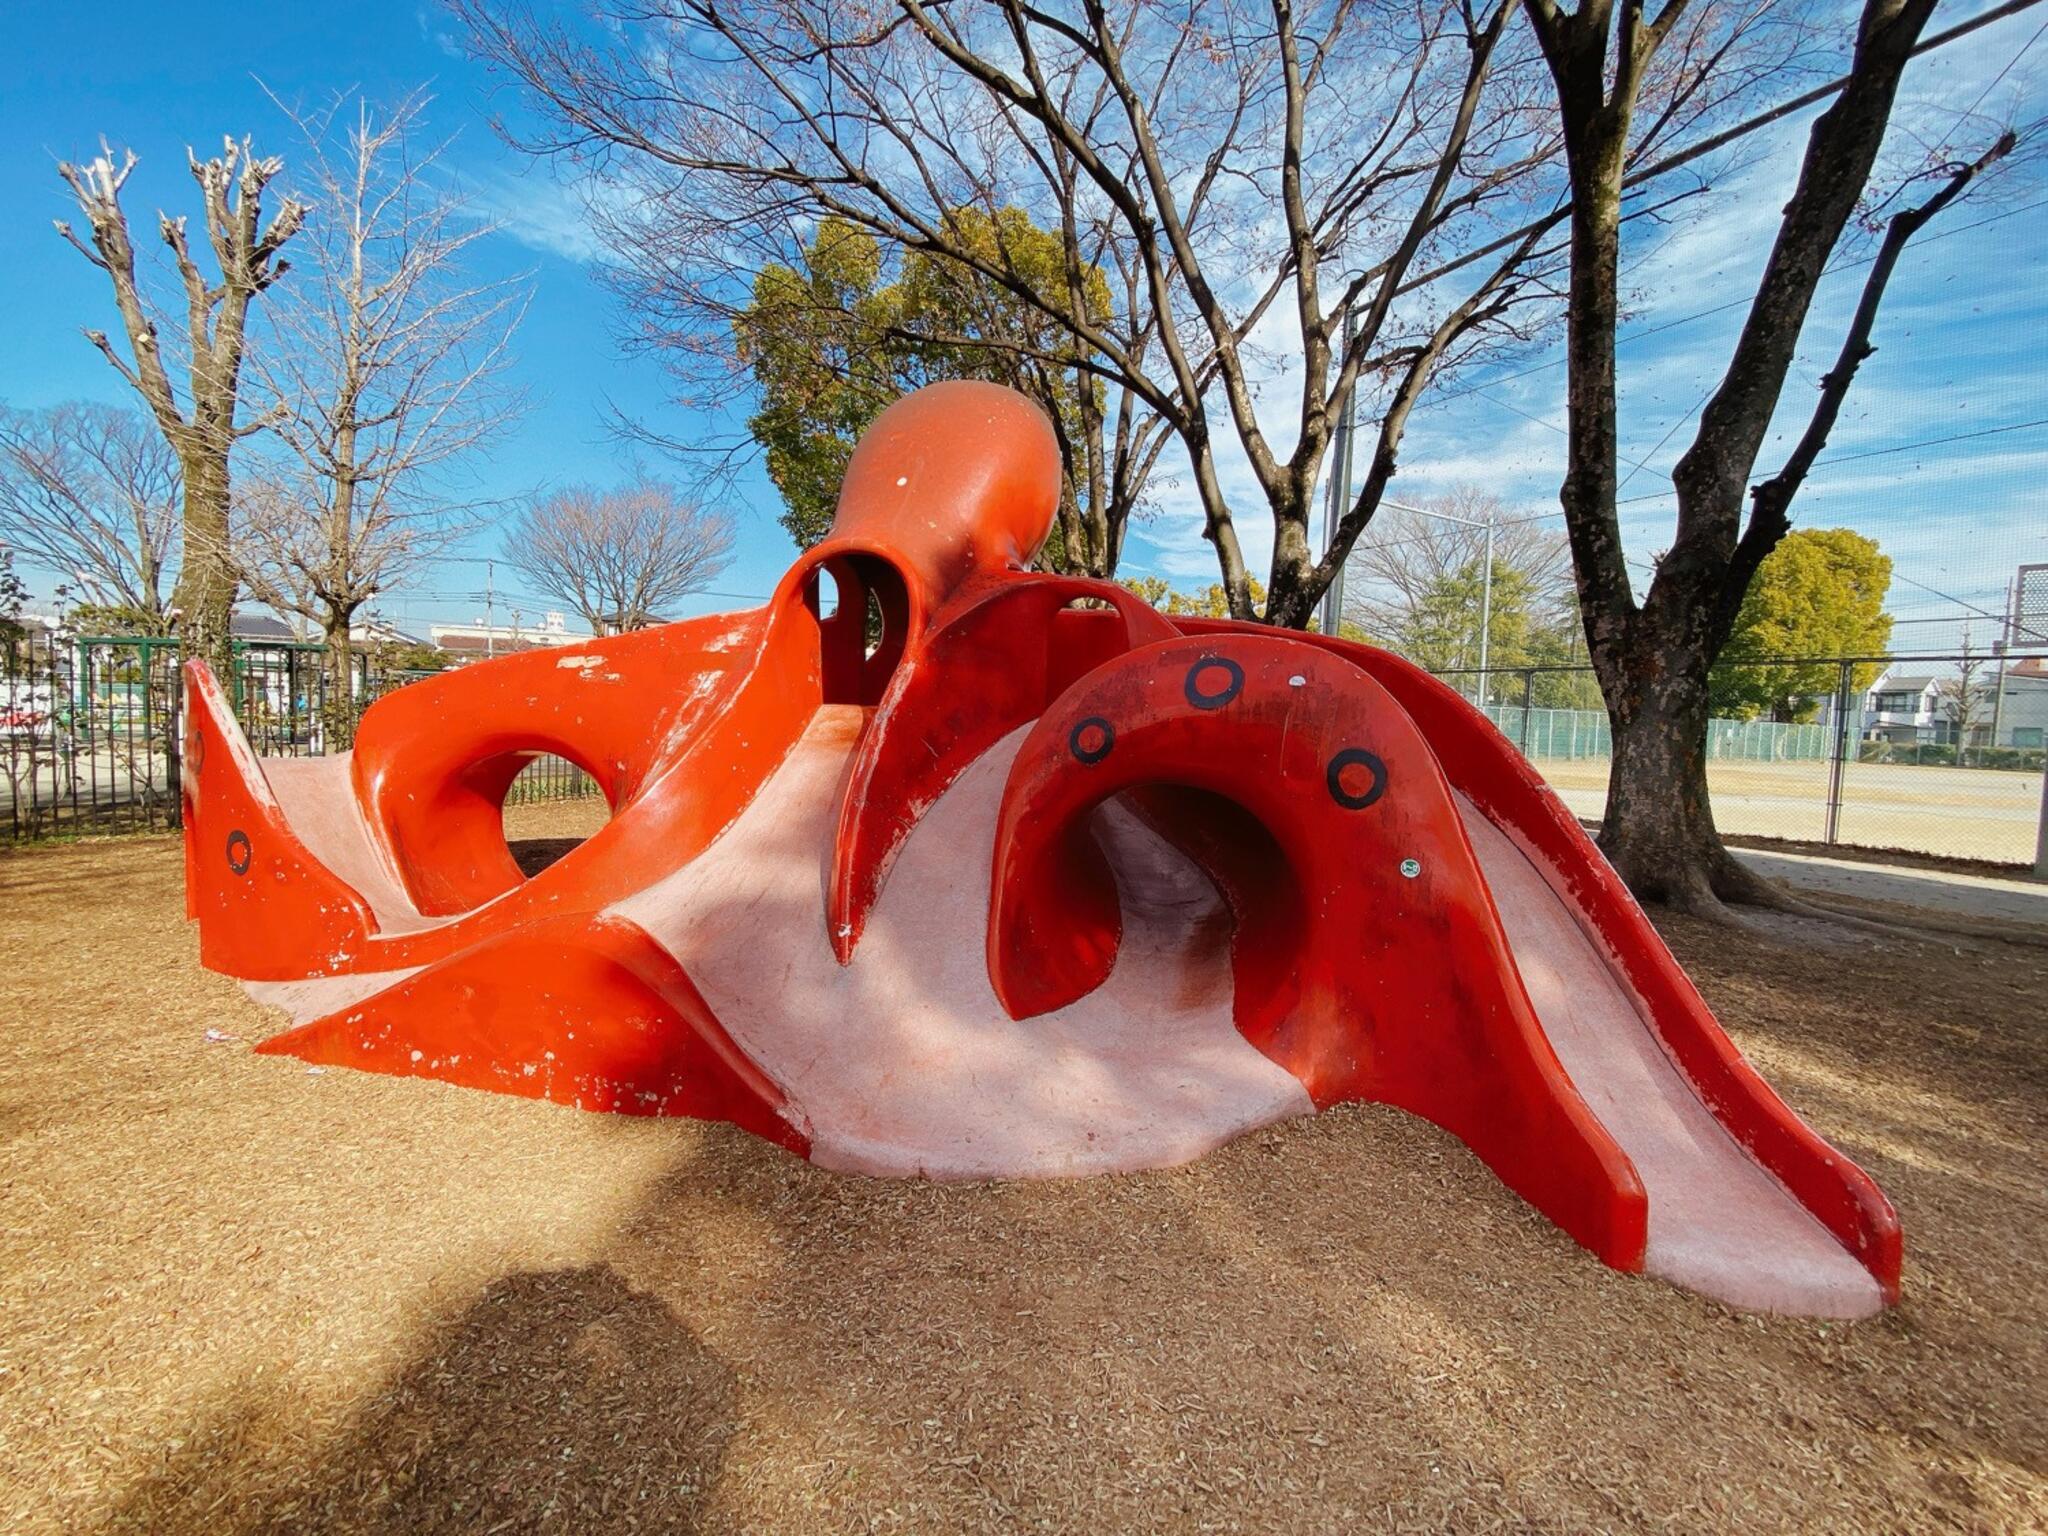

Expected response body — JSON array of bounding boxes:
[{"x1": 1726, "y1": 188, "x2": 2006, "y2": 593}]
[{"x1": 106, "y1": 1264, "x2": 737, "y2": 1536}]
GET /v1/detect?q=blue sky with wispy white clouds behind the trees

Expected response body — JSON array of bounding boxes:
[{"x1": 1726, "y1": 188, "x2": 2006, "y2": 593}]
[{"x1": 0, "y1": 0, "x2": 2048, "y2": 649}]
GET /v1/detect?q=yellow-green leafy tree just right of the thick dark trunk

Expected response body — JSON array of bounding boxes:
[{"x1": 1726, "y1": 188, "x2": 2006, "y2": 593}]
[{"x1": 1708, "y1": 528, "x2": 1892, "y2": 721}]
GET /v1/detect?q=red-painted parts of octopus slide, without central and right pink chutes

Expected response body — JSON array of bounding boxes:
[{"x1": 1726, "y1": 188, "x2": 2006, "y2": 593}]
[{"x1": 184, "y1": 383, "x2": 1898, "y2": 1296}]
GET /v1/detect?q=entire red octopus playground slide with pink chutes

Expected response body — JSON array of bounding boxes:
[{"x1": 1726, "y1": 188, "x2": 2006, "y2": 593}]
[{"x1": 184, "y1": 383, "x2": 1901, "y2": 1317}]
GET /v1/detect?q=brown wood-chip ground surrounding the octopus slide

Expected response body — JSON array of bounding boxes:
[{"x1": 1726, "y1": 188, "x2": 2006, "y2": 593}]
[{"x1": 0, "y1": 807, "x2": 2048, "y2": 1532}]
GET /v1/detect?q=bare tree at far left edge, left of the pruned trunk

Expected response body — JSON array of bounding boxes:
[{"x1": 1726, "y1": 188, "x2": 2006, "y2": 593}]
[{"x1": 0, "y1": 401, "x2": 182, "y2": 635}]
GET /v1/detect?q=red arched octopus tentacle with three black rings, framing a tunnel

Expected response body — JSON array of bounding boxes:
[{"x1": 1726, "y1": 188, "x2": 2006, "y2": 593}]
[{"x1": 989, "y1": 633, "x2": 1645, "y2": 1270}]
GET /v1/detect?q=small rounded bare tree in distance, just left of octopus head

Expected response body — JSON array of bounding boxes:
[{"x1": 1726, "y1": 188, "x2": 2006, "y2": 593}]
[{"x1": 504, "y1": 479, "x2": 735, "y2": 635}]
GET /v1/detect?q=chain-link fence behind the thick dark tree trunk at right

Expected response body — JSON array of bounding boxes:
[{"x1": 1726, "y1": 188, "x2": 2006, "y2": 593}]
[{"x1": 1438, "y1": 651, "x2": 2048, "y2": 866}]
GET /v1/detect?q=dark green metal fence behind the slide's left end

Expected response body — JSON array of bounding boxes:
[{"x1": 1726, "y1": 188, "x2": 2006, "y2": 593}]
[{"x1": 0, "y1": 631, "x2": 596, "y2": 842}]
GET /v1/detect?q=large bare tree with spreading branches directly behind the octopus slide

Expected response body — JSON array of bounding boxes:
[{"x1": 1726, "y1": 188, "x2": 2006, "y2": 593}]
[{"x1": 455, "y1": 0, "x2": 1802, "y2": 625}]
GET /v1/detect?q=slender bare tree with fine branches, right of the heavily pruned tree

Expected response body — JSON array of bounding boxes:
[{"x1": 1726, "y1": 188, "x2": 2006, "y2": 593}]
[{"x1": 233, "y1": 92, "x2": 528, "y2": 750}]
